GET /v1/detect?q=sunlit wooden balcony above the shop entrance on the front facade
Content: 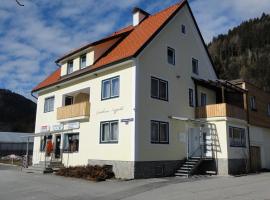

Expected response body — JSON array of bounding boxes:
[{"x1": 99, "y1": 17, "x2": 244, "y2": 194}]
[{"x1": 57, "y1": 102, "x2": 90, "y2": 121}]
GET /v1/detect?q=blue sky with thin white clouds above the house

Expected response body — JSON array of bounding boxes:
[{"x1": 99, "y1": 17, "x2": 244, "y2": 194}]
[{"x1": 0, "y1": 0, "x2": 270, "y2": 98}]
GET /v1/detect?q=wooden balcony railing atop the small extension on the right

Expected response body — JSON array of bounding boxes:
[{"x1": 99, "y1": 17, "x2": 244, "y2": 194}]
[{"x1": 195, "y1": 103, "x2": 247, "y2": 120}]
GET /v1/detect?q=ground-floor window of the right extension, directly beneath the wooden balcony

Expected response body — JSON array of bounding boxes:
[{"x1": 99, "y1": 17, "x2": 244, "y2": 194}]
[{"x1": 229, "y1": 126, "x2": 246, "y2": 147}]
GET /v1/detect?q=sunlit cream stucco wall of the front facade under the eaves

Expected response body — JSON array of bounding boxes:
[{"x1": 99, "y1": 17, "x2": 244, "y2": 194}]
[{"x1": 33, "y1": 63, "x2": 136, "y2": 165}]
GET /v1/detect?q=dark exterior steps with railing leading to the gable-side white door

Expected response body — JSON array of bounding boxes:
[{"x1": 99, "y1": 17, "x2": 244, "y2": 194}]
[{"x1": 174, "y1": 157, "x2": 203, "y2": 177}]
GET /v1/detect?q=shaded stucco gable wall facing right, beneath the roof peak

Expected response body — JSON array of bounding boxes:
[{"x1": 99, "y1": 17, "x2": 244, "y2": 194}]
[{"x1": 136, "y1": 4, "x2": 216, "y2": 161}]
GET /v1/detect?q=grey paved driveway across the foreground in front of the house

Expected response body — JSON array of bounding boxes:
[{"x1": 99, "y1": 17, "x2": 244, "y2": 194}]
[{"x1": 0, "y1": 166, "x2": 270, "y2": 200}]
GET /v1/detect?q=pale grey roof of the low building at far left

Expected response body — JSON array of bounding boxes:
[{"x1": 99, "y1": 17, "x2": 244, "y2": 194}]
[{"x1": 0, "y1": 132, "x2": 34, "y2": 143}]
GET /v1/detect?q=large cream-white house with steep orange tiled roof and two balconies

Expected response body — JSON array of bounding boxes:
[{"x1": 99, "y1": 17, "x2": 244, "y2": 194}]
[{"x1": 33, "y1": 1, "x2": 270, "y2": 178}]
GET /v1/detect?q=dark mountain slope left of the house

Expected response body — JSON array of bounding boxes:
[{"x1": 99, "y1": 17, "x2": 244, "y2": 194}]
[{"x1": 0, "y1": 89, "x2": 36, "y2": 132}]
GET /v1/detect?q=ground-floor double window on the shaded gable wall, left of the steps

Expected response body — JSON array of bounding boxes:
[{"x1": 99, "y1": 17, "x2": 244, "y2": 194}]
[{"x1": 151, "y1": 120, "x2": 169, "y2": 144}]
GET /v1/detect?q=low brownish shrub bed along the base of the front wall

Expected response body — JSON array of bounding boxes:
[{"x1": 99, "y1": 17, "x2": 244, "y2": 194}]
[{"x1": 56, "y1": 165, "x2": 114, "y2": 181}]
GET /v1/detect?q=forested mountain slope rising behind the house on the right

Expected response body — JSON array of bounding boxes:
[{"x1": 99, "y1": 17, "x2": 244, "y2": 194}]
[{"x1": 208, "y1": 14, "x2": 270, "y2": 91}]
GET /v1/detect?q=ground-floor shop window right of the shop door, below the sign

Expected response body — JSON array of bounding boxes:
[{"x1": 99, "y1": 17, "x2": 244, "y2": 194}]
[{"x1": 63, "y1": 133, "x2": 79, "y2": 153}]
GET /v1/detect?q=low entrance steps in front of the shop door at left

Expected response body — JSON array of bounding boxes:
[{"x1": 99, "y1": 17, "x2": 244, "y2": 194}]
[{"x1": 23, "y1": 161, "x2": 64, "y2": 174}]
